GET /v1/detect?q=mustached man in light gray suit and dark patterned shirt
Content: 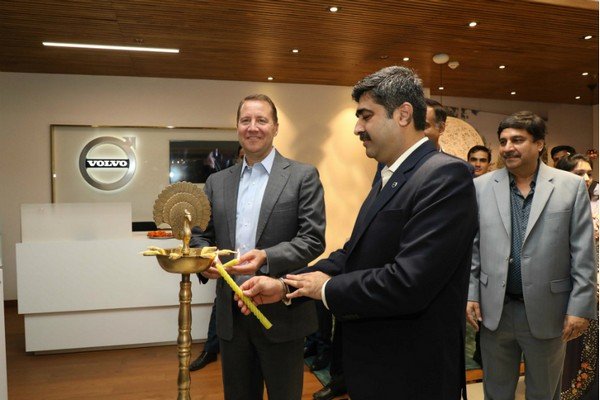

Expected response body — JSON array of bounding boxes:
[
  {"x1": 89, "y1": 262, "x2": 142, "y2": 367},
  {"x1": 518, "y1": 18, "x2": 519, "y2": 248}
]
[{"x1": 466, "y1": 111, "x2": 596, "y2": 400}]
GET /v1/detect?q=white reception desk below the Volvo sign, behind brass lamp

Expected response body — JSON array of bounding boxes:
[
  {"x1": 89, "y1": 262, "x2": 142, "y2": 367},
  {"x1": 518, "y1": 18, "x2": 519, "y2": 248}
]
[{"x1": 16, "y1": 203, "x2": 215, "y2": 352}]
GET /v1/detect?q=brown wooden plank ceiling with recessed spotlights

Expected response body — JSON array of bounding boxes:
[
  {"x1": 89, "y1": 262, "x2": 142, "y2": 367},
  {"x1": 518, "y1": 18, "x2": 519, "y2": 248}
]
[{"x1": 0, "y1": 0, "x2": 598, "y2": 104}]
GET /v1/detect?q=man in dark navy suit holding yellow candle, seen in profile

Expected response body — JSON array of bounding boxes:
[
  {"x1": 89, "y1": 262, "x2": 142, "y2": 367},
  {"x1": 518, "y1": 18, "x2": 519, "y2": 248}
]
[{"x1": 238, "y1": 67, "x2": 477, "y2": 400}]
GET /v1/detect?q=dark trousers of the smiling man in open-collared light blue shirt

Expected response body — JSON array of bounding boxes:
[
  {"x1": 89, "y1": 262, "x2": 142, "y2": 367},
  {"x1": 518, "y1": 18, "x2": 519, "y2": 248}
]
[{"x1": 219, "y1": 310, "x2": 304, "y2": 400}]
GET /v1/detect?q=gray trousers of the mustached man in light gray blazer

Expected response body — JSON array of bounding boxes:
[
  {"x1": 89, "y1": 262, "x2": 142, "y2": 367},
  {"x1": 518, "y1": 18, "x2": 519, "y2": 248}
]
[{"x1": 481, "y1": 300, "x2": 566, "y2": 400}]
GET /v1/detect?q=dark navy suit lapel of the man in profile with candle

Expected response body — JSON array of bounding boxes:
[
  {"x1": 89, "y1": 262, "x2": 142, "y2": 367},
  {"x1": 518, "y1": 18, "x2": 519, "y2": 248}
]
[{"x1": 348, "y1": 141, "x2": 437, "y2": 252}]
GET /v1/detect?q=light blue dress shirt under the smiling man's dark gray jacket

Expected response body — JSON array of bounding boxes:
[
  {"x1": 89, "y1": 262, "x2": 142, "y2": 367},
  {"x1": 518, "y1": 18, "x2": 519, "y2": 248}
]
[{"x1": 235, "y1": 148, "x2": 275, "y2": 283}]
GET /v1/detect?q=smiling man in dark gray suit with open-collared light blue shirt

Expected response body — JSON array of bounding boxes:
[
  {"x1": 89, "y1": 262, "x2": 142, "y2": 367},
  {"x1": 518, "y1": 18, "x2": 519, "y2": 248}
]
[{"x1": 191, "y1": 95, "x2": 325, "y2": 400}]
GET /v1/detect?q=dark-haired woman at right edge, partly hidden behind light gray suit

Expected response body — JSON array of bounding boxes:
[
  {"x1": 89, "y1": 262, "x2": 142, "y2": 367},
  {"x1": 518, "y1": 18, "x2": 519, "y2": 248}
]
[{"x1": 556, "y1": 154, "x2": 598, "y2": 400}]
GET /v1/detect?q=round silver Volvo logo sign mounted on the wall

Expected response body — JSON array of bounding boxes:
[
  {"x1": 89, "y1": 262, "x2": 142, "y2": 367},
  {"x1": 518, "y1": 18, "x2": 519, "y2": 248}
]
[{"x1": 79, "y1": 136, "x2": 136, "y2": 191}]
